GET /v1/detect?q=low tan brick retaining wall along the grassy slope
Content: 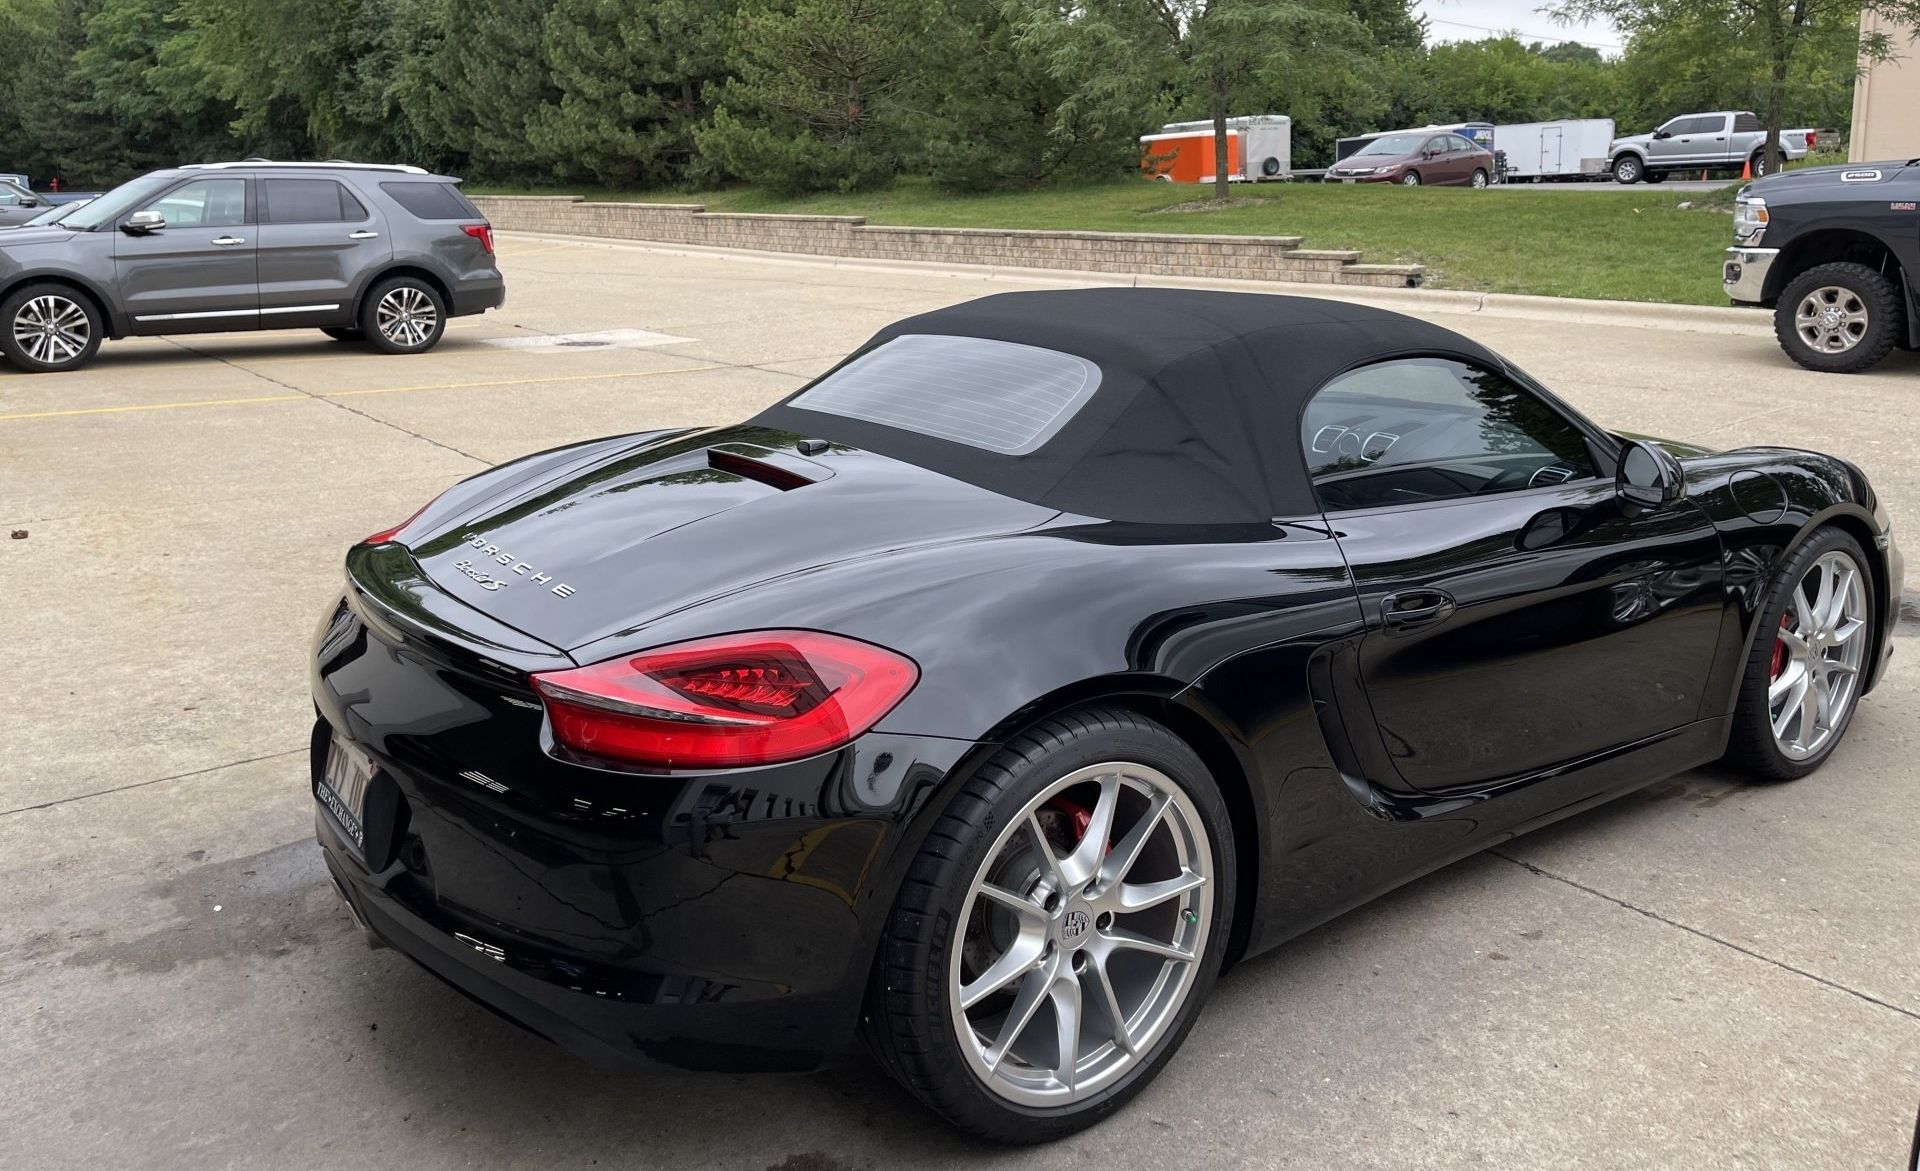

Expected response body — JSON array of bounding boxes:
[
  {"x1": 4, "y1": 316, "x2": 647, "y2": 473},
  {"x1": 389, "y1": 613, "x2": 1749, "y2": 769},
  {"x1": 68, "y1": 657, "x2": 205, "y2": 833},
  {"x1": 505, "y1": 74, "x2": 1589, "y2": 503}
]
[{"x1": 474, "y1": 196, "x2": 1427, "y2": 288}]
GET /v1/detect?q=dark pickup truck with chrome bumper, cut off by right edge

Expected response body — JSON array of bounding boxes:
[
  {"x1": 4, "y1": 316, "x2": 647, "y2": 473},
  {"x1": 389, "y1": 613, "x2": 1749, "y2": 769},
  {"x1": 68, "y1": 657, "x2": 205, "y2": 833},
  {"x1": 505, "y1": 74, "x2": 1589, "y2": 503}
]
[{"x1": 1720, "y1": 159, "x2": 1920, "y2": 374}]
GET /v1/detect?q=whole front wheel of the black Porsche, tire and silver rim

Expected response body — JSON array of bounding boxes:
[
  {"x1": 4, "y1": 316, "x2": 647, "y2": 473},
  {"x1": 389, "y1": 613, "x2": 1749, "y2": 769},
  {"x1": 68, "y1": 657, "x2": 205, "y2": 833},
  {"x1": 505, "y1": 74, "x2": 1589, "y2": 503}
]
[{"x1": 1726, "y1": 528, "x2": 1876, "y2": 781}]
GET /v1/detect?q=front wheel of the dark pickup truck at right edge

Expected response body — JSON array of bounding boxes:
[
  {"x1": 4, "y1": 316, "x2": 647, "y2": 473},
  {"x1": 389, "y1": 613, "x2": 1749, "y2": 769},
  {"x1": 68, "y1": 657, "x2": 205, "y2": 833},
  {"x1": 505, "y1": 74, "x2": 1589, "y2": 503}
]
[{"x1": 1774, "y1": 261, "x2": 1905, "y2": 374}]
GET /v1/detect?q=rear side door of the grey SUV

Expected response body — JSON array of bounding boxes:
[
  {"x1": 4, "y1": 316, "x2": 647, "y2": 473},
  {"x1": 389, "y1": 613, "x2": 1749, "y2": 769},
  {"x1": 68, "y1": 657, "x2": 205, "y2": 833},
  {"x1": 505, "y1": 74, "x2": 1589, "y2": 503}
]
[{"x1": 255, "y1": 179, "x2": 394, "y2": 328}]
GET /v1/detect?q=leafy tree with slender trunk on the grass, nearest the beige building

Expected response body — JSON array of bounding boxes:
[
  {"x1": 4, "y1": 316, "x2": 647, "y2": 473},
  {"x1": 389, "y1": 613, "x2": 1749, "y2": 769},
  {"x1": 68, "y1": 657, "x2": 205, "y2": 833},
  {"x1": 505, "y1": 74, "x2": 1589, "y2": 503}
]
[{"x1": 1553, "y1": 0, "x2": 1920, "y2": 171}]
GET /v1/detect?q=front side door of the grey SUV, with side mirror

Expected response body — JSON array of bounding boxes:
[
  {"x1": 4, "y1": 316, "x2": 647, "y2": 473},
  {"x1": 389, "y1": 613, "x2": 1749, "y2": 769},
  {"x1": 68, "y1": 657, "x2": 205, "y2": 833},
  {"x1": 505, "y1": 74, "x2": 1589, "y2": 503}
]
[{"x1": 113, "y1": 175, "x2": 259, "y2": 334}]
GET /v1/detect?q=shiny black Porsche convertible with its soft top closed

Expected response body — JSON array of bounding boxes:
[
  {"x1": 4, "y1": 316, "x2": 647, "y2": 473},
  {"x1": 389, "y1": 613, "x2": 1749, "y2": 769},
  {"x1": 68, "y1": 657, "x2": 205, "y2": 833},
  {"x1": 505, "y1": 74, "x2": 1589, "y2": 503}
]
[{"x1": 311, "y1": 290, "x2": 1903, "y2": 1140}]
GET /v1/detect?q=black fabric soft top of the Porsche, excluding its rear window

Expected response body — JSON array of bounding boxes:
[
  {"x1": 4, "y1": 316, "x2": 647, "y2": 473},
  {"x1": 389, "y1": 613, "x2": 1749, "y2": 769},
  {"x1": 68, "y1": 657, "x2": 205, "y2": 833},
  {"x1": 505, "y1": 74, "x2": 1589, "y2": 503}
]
[{"x1": 753, "y1": 288, "x2": 1500, "y2": 524}]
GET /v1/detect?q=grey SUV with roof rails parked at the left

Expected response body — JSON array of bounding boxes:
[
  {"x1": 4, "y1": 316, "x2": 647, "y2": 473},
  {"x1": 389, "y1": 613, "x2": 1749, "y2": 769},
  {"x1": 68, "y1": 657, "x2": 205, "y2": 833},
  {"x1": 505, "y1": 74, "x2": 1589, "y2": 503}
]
[{"x1": 0, "y1": 159, "x2": 507, "y2": 372}]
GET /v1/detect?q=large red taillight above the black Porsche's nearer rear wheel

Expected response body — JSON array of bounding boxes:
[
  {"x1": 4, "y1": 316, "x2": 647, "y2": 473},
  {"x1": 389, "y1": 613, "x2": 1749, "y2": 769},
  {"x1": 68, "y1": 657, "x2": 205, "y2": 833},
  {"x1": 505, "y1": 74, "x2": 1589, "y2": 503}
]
[{"x1": 534, "y1": 630, "x2": 920, "y2": 768}]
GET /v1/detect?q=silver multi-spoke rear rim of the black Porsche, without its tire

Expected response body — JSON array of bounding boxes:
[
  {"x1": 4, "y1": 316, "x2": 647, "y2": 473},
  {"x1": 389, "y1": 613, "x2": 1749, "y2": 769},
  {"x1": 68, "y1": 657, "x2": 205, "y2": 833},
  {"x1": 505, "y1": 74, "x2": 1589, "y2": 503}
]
[{"x1": 947, "y1": 762, "x2": 1213, "y2": 1106}]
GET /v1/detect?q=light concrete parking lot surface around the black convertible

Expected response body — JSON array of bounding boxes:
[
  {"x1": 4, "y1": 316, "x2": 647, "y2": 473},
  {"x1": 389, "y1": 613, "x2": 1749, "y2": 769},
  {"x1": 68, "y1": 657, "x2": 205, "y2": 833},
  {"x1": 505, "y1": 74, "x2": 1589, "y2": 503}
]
[{"x1": 0, "y1": 236, "x2": 1920, "y2": 1171}]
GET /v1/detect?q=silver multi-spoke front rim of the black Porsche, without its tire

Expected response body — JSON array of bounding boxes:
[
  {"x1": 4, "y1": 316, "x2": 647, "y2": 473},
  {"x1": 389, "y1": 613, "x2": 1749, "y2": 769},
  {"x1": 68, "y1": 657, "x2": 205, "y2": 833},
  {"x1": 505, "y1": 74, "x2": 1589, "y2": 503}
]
[{"x1": 1766, "y1": 549, "x2": 1866, "y2": 760}]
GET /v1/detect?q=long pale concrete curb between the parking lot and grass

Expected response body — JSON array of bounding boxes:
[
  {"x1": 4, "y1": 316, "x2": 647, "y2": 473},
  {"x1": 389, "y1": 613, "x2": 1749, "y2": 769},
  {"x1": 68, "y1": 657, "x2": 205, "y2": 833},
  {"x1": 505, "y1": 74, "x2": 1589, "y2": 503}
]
[{"x1": 499, "y1": 230, "x2": 1774, "y2": 338}]
